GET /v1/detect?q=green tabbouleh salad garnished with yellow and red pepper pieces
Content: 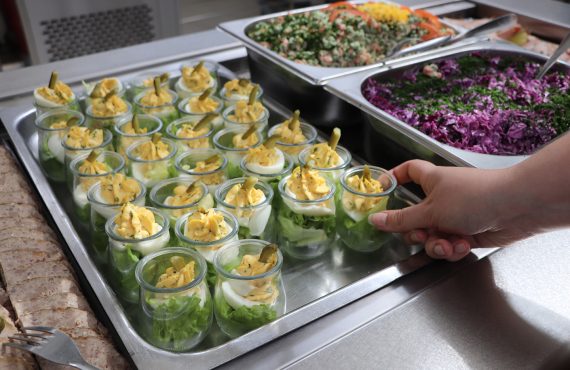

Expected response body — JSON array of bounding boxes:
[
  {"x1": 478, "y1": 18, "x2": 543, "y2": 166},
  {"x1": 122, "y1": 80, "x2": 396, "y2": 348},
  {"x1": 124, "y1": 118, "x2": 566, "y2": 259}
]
[{"x1": 247, "y1": 2, "x2": 453, "y2": 67}]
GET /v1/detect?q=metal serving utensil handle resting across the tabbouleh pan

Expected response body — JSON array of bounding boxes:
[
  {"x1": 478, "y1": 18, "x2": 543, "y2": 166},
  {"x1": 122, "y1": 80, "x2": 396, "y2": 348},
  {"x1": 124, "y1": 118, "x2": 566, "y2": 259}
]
[{"x1": 389, "y1": 14, "x2": 517, "y2": 58}]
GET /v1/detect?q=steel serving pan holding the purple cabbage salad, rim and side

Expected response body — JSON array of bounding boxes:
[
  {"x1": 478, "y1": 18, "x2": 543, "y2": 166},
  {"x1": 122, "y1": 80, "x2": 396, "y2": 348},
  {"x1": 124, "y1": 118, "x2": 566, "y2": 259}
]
[{"x1": 325, "y1": 41, "x2": 570, "y2": 169}]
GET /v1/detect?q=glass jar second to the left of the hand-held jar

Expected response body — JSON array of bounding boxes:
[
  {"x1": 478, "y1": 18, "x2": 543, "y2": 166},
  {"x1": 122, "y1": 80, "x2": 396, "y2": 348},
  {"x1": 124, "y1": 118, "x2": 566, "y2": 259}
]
[{"x1": 215, "y1": 177, "x2": 276, "y2": 242}]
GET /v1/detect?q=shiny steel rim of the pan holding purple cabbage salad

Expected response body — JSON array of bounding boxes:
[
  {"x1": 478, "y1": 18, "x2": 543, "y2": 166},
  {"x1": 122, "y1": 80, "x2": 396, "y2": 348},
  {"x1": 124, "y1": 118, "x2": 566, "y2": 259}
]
[{"x1": 323, "y1": 41, "x2": 570, "y2": 168}]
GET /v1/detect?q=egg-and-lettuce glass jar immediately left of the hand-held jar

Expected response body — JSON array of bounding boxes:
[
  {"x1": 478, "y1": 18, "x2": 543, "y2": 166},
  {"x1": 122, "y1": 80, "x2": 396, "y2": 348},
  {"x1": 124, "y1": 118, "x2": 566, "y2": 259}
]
[{"x1": 277, "y1": 167, "x2": 336, "y2": 259}]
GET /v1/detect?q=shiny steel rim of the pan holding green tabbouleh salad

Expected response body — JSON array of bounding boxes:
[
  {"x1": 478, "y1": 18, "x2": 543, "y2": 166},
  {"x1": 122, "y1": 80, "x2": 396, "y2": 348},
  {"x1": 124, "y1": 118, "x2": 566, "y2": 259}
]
[{"x1": 218, "y1": 0, "x2": 464, "y2": 85}]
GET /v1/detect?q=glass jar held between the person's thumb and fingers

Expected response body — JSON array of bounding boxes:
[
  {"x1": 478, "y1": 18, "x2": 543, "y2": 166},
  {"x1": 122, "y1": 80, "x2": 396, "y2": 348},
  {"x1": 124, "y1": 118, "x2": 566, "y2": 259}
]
[{"x1": 336, "y1": 166, "x2": 397, "y2": 252}]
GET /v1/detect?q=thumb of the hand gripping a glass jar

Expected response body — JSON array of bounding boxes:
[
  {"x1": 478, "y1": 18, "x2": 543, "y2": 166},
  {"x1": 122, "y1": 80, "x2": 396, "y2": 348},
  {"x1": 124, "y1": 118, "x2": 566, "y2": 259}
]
[{"x1": 368, "y1": 204, "x2": 430, "y2": 233}]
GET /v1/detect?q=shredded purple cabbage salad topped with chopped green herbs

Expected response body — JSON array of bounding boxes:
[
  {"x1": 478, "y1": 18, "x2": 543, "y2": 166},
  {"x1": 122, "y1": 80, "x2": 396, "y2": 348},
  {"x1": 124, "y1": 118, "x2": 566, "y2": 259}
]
[{"x1": 362, "y1": 53, "x2": 570, "y2": 155}]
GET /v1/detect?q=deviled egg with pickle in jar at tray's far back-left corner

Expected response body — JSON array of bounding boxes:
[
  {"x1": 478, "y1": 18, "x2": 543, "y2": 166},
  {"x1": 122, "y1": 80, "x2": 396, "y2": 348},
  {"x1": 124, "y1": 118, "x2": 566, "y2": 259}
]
[{"x1": 34, "y1": 72, "x2": 79, "y2": 116}]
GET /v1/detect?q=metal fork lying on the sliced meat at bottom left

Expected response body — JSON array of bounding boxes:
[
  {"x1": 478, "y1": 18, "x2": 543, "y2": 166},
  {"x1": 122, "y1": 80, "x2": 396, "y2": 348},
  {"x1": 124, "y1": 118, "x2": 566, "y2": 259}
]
[{"x1": 3, "y1": 326, "x2": 98, "y2": 370}]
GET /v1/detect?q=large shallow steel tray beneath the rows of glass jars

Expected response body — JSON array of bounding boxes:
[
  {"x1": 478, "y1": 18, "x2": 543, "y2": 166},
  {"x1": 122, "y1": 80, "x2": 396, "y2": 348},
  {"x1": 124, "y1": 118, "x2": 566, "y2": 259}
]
[{"x1": 0, "y1": 56, "x2": 440, "y2": 369}]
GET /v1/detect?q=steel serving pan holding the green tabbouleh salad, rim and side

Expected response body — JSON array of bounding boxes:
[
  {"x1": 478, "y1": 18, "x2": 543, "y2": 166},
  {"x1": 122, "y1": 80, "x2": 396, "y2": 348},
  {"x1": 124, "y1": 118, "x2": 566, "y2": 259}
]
[{"x1": 218, "y1": 1, "x2": 466, "y2": 127}]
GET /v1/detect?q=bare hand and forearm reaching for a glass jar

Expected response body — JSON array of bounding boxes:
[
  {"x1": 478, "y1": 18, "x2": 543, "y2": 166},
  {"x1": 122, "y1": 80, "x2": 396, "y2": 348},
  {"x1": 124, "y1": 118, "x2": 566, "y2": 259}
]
[{"x1": 370, "y1": 135, "x2": 570, "y2": 261}]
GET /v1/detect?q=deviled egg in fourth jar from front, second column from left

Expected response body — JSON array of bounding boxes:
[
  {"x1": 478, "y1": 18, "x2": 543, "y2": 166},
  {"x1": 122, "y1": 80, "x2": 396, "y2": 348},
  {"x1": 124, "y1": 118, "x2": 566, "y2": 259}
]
[{"x1": 127, "y1": 133, "x2": 177, "y2": 189}]
